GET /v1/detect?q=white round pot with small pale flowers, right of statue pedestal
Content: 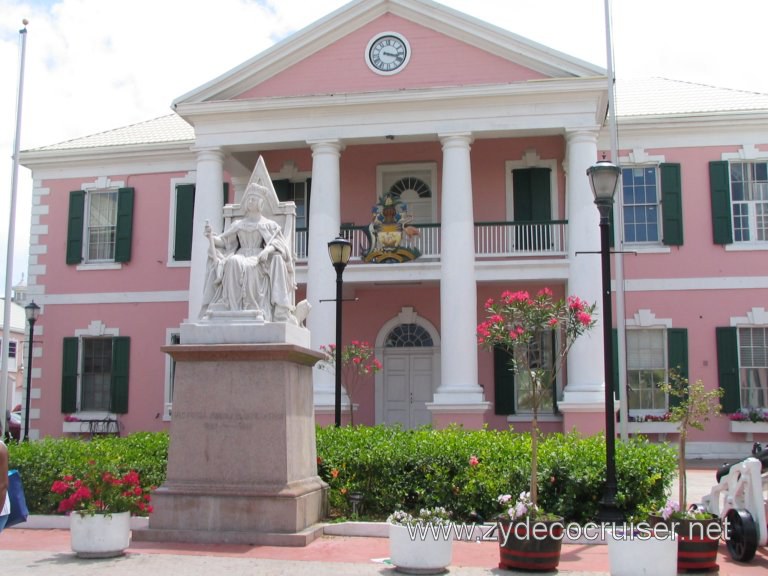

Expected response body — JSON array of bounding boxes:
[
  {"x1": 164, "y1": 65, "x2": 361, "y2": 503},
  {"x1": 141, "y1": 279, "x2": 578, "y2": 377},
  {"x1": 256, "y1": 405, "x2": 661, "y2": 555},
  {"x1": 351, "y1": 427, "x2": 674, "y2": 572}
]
[{"x1": 387, "y1": 506, "x2": 453, "y2": 574}]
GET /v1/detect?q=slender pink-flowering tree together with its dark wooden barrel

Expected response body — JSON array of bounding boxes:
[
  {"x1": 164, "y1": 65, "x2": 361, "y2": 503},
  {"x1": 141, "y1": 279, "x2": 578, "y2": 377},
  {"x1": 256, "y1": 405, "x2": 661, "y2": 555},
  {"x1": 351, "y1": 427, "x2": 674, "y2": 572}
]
[{"x1": 477, "y1": 288, "x2": 596, "y2": 570}]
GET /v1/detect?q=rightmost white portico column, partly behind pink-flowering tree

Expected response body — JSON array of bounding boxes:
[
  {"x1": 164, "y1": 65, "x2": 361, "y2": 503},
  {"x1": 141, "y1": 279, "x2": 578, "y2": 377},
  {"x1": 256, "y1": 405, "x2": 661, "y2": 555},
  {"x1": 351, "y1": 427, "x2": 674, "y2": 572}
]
[{"x1": 558, "y1": 129, "x2": 605, "y2": 412}]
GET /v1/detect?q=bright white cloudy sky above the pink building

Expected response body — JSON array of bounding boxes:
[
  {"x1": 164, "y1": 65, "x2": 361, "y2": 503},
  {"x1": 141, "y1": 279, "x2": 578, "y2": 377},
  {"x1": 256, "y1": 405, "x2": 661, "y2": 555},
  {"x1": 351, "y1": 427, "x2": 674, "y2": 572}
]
[{"x1": 0, "y1": 0, "x2": 768, "y2": 283}]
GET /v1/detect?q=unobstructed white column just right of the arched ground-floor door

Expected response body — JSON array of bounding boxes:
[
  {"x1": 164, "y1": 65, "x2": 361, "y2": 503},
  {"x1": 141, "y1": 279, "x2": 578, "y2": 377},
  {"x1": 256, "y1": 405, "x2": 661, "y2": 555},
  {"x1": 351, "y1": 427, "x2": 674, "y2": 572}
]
[{"x1": 431, "y1": 134, "x2": 485, "y2": 410}]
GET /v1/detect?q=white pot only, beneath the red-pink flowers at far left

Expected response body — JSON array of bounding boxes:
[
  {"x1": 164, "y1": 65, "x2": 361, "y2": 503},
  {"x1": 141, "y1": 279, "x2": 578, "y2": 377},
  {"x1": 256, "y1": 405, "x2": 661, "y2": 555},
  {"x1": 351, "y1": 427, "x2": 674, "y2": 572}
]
[{"x1": 69, "y1": 512, "x2": 131, "y2": 558}]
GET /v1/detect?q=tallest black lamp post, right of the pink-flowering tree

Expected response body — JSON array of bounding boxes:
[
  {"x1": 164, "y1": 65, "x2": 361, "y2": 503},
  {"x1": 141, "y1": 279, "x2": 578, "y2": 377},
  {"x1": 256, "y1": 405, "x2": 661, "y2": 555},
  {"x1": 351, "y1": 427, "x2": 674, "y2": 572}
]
[{"x1": 587, "y1": 160, "x2": 623, "y2": 522}]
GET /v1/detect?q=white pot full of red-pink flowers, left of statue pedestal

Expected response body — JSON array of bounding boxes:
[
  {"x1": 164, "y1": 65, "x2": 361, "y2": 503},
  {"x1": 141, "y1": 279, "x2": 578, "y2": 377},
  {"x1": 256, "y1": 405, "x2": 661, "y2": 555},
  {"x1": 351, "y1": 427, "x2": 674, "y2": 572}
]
[{"x1": 51, "y1": 462, "x2": 152, "y2": 558}]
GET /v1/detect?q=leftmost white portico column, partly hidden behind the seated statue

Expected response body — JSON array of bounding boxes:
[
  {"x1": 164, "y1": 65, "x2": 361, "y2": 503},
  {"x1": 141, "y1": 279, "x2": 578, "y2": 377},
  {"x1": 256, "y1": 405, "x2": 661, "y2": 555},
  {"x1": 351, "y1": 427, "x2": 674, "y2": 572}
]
[{"x1": 188, "y1": 148, "x2": 224, "y2": 322}]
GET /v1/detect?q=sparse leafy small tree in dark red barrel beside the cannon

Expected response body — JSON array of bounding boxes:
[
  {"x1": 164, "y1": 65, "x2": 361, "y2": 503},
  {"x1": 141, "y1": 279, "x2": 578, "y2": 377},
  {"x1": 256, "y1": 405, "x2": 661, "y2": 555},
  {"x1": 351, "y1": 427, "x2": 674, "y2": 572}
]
[{"x1": 661, "y1": 370, "x2": 723, "y2": 570}]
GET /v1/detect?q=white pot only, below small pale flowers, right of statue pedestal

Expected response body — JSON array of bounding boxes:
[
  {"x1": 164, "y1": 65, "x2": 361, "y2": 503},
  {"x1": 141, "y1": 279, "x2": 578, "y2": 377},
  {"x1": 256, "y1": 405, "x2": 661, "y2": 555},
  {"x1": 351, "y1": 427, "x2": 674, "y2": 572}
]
[{"x1": 389, "y1": 524, "x2": 453, "y2": 574}]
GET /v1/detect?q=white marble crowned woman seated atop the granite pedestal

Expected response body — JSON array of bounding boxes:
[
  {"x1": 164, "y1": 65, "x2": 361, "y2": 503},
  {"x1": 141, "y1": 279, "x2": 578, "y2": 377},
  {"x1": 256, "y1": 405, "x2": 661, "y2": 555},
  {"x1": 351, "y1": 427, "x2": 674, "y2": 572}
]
[{"x1": 202, "y1": 183, "x2": 298, "y2": 324}]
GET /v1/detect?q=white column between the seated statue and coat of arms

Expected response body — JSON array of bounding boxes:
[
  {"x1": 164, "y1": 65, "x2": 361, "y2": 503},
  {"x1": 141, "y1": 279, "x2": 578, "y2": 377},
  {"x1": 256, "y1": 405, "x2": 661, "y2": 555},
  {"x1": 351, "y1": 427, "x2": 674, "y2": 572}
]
[{"x1": 307, "y1": 140, "x2": 346, "y2": 409}]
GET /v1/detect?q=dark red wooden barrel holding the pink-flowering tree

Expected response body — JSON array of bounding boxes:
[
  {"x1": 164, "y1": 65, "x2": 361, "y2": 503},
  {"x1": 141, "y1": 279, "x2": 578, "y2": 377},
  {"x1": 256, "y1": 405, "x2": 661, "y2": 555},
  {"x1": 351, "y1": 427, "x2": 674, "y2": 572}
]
[{"x1": 497, "y1": 518, "x2": 563, "y2": 572}]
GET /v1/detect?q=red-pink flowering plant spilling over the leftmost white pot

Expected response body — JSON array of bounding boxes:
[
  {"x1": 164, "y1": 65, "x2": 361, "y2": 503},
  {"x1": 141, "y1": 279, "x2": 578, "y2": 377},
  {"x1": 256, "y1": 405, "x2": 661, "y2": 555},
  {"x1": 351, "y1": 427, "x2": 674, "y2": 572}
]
[{"x1": 51, "y1": 462, "x2": 152, "y2": 516}]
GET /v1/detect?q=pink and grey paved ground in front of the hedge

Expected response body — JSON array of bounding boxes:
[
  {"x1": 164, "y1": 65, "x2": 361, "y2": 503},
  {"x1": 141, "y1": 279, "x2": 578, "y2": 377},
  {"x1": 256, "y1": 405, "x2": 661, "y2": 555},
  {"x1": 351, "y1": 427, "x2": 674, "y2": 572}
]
[{"x1": 0, "y1": 468, "x2": 768, "y2": 576}]
